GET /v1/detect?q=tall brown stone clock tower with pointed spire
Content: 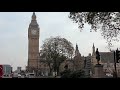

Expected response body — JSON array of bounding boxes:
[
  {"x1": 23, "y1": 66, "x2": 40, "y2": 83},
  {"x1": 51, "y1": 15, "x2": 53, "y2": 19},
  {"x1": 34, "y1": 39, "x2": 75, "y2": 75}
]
[{"x1": 28, "y1": 12, "x2": 39, "y2": 71}]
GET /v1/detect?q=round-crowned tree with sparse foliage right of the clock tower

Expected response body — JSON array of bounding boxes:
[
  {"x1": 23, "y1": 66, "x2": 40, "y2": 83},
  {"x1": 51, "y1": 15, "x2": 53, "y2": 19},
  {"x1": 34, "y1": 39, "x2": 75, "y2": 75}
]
[{"x1": 40, "y1": 36, "x2": 74, "y2": 74}]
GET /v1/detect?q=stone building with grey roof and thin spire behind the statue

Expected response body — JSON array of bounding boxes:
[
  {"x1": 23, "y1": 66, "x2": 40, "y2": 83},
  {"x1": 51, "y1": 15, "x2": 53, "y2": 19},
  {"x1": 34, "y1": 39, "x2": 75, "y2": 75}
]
[{"x1": 91, "y1": 44, "x2": 120, "y2": 77}]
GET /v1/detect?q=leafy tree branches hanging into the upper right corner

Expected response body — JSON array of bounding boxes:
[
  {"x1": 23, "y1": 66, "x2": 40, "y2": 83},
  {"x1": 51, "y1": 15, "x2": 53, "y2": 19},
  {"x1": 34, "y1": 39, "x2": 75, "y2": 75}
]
[{"x1": 69, "y1": 12, "x2": 120, "y2": 45}]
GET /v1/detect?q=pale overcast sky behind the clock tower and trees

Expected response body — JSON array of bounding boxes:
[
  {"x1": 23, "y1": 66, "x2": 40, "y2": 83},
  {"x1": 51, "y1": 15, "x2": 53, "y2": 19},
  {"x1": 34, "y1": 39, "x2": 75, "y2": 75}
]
[{"x1": 0, "y1": 12, "x2": 118, "y2": 70}]
